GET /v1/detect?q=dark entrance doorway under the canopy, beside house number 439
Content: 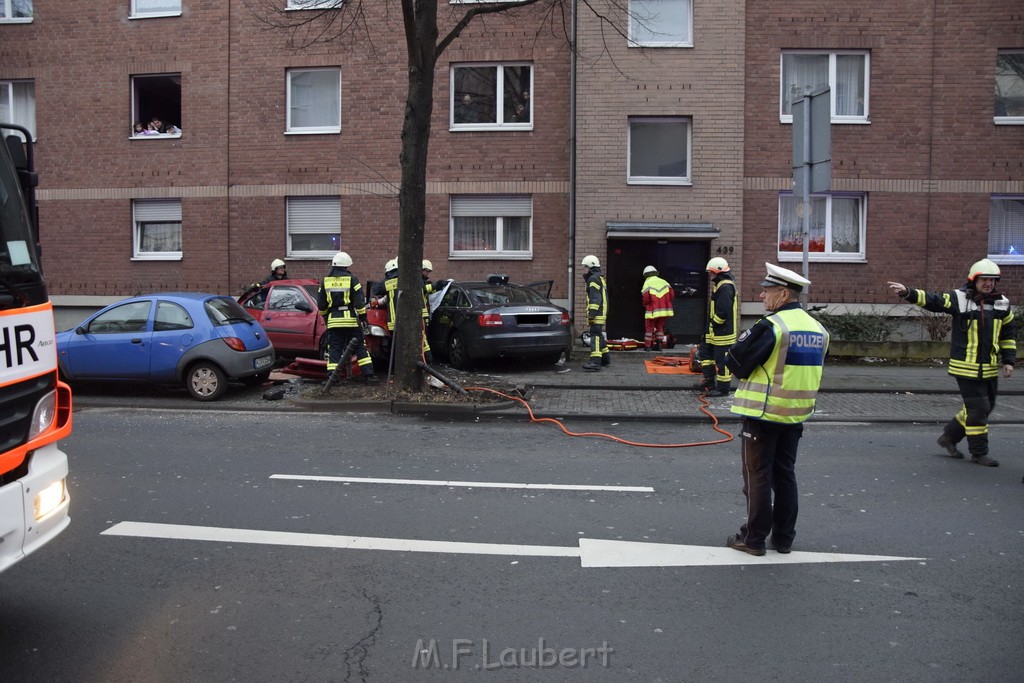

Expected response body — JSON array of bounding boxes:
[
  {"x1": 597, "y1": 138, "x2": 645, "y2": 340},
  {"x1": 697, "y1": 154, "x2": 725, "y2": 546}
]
[{"x1": 604, "y1": 240, "x2": 709, "y2": 344}]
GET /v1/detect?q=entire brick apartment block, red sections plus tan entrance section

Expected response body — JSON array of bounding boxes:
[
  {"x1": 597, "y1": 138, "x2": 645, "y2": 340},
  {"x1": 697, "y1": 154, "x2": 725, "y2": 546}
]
[{"x1": 0, "y1": 0, "x2": 1024, "y2": 340}]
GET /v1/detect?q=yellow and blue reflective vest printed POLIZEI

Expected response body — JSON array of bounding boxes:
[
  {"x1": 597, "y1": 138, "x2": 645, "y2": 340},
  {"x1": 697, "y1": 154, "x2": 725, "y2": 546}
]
[{"x1": 730, "y1": 306, "x2": 828, "y2": 424}]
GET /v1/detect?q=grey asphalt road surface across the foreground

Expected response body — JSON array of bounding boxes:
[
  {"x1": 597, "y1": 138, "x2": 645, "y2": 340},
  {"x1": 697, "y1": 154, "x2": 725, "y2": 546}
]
[{"x1": 0, "y1": 408, "x2": 1024, "y2": 681}]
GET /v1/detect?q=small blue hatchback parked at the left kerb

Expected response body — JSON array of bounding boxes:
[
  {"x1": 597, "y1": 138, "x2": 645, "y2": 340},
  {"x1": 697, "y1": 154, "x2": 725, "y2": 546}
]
[{"x1": 56, "y1": 292, "x2": 274, "y2": 400}]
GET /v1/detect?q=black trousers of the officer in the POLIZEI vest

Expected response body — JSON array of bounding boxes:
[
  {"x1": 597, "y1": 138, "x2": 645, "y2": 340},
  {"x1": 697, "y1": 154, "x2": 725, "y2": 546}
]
[{"x1": 739, "y1": 418, "x2": 804, "y2": 548}]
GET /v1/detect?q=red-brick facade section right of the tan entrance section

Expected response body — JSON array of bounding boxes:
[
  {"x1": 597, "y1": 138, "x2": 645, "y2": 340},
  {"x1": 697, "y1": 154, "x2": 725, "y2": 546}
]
[{"x1": 742, "y1": 0, "x2": 1024, "y2": 321}]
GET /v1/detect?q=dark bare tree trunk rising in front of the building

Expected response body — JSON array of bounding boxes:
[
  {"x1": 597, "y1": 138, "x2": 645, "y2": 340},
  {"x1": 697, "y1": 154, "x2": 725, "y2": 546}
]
[{"x1": 394, "y1": 0, "x2": 437, "y2": 391}]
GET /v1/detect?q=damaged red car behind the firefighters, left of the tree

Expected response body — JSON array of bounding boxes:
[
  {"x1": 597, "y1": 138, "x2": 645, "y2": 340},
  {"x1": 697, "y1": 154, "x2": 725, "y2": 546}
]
[{"x1": 239, "y1": 280, "x2": 390, "y2": 364}]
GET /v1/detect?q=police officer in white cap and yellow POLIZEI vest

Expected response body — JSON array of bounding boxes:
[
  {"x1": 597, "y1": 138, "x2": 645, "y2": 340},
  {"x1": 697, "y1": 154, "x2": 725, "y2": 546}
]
[{"x1": 726, "y1": 263, "x2": 828, "y2": 555}]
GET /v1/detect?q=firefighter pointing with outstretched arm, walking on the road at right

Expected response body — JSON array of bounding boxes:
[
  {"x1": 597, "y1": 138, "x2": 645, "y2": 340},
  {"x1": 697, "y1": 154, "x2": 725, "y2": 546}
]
[{"x1": 889, "y1": 258, "x2": 1019, "y2": 467}]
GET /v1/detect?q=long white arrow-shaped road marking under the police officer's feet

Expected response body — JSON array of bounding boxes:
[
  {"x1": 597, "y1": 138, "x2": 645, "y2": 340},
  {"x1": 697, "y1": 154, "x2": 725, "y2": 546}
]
[{"x1": 102, "y1": 521, "x2": 926, "y2": 568}]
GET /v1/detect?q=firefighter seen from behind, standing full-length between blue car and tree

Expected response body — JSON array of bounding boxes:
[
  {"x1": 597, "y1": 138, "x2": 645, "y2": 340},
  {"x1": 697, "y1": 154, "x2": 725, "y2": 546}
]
[{"x1": 316, "y1": 251, "x2": 377, "y2": 382}]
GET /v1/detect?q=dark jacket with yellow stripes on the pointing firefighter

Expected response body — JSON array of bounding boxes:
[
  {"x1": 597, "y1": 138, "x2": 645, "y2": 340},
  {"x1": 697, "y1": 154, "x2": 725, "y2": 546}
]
[{"x1": 904, "y1": 287, "x2": 1020, "y2": 380}]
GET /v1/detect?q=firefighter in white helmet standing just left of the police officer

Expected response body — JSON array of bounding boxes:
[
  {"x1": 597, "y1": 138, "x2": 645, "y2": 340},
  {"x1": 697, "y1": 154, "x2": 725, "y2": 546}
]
[{"x1": 697, "y1": 256, "x2": 739, "y2": 396}]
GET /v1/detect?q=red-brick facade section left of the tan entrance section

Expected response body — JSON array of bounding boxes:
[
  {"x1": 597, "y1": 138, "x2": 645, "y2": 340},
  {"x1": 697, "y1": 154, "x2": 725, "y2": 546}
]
[{"x1": 0, "y1": 0, "x2": 569, "y2": 321}]
